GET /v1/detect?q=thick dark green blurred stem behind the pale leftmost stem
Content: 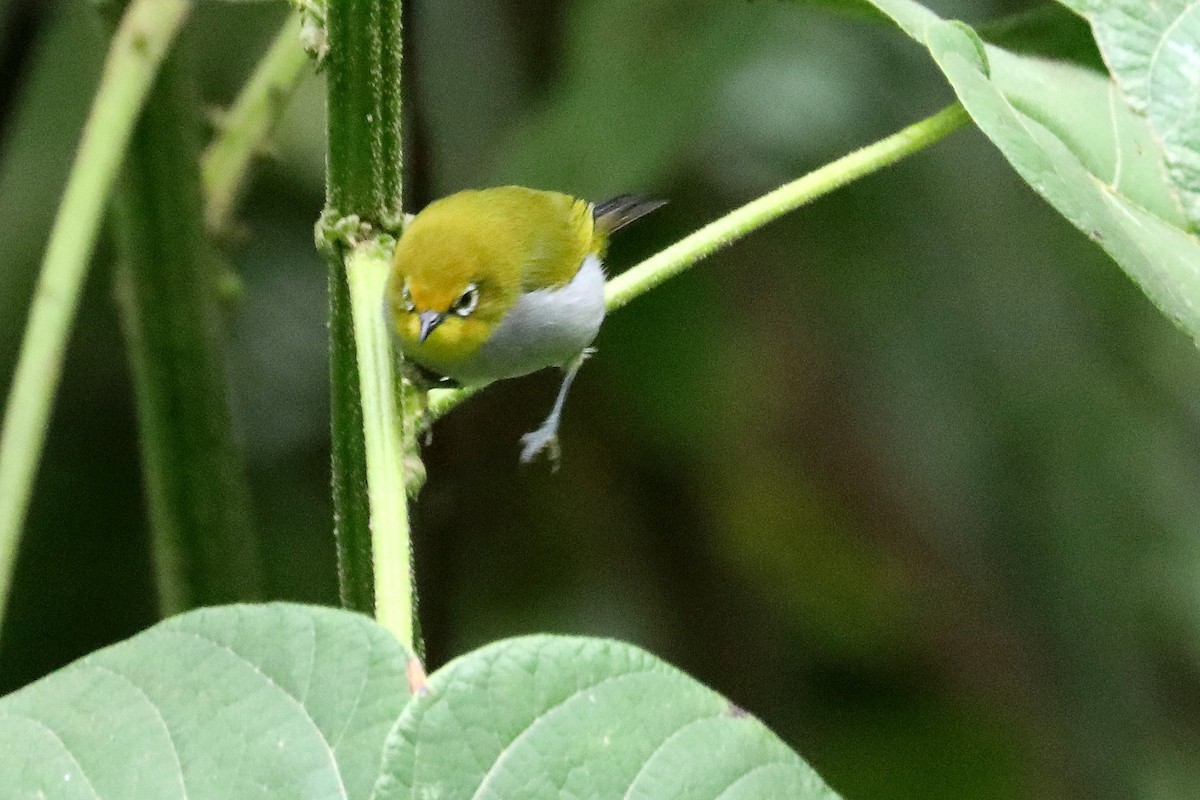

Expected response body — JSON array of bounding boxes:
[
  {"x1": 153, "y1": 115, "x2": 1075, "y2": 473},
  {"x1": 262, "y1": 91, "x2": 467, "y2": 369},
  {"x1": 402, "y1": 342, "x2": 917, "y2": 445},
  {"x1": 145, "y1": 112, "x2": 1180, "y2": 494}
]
[{"x1": 113, "y1": 32, "x2": 262, "y2": 615}]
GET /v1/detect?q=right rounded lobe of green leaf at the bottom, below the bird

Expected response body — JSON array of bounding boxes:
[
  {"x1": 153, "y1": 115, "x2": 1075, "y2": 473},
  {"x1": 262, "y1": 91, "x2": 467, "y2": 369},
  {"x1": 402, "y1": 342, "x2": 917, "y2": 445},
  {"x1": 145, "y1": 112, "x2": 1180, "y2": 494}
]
[{"x1": 373, "y1": 636, "x2": 838, "y2": 800}]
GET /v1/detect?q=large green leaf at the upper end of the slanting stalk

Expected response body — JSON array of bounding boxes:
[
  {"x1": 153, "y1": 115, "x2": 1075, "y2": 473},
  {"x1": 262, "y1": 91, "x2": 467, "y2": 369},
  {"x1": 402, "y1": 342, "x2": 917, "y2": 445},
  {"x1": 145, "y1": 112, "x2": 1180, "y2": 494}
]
[{"x1": 872, "y1": 0, "x2": 1200, "y2": 342}]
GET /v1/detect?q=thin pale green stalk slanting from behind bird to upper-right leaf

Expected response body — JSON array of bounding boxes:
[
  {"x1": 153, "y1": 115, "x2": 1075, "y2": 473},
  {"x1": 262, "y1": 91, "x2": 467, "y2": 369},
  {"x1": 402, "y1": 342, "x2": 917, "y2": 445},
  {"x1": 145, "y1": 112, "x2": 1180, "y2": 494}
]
[{"x1": 427, "y1": 103, "x2": 970, "y2": 422}]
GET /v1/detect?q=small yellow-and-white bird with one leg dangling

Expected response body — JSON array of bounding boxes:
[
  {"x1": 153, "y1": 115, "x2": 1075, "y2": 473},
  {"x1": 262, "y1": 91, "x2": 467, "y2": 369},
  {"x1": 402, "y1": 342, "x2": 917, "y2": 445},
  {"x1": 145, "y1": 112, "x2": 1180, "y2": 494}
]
[{"x1": 388, "y1": 186, "x2": 664, "y2": 464}]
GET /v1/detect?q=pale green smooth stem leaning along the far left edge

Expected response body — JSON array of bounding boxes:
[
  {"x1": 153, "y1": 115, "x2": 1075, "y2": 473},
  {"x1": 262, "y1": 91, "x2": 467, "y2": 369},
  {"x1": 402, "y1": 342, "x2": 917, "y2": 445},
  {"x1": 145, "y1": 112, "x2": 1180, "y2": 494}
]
[{"x1": 0, "y1": 0, "x2": 192, "y2": 612}]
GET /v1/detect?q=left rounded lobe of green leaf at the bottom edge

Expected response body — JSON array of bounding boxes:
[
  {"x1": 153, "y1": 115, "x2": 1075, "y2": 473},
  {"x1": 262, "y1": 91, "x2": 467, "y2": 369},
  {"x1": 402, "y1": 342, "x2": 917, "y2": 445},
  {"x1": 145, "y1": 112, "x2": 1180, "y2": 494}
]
[{"x1": 0, "y1": 604, "x2": 408, "y2": 800}]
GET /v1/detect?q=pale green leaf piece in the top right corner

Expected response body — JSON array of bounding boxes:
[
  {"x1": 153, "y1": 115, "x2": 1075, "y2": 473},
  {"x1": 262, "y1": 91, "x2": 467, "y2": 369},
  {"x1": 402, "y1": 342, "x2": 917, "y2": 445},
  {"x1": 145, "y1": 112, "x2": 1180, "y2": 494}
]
[{"x1": 1067, "y1": 0, "x2": 1200, "y2": 227}]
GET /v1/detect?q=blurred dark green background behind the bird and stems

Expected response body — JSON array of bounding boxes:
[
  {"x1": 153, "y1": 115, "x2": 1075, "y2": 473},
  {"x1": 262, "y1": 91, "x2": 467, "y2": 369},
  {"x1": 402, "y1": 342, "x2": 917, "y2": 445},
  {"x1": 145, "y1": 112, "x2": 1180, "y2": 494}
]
[{"x1": 0, "y1": 0, "x2": 1200, "y2": 800}]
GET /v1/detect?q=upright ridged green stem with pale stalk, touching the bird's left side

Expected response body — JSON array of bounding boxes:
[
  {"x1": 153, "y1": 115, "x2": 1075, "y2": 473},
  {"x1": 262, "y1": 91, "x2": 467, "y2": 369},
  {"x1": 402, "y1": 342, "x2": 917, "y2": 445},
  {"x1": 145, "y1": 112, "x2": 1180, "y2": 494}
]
[{"x1": 318, "y1": 0, "x2": 414, "y2": 649}]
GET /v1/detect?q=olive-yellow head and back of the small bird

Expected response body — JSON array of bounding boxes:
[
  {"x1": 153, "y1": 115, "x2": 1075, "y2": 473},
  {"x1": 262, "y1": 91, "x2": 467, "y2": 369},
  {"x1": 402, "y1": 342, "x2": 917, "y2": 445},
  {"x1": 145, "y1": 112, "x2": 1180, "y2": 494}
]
[{"x1": 388, "y1": 186, "x2": 602, "y2": 377}]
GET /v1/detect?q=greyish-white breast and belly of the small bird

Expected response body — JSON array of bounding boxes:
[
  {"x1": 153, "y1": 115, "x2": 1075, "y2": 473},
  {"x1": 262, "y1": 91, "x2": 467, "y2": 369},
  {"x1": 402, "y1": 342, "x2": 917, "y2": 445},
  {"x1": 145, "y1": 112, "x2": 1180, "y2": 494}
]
[{"x1": 455, "y1": 254, "x2": 604, "y2": 384}]
